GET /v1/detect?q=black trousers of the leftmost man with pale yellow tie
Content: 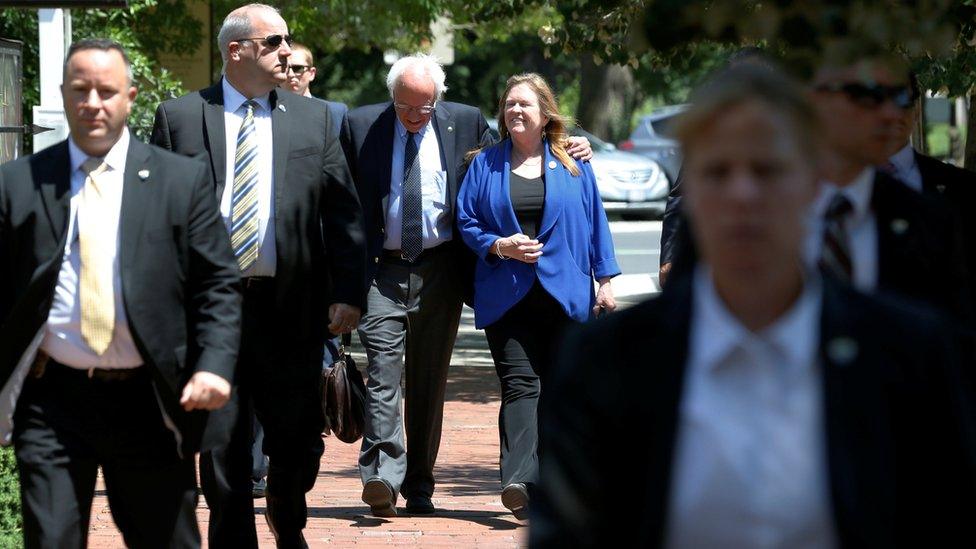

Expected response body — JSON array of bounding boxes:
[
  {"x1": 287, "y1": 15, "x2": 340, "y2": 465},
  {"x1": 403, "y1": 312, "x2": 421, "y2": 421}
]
[{"x1": 14, "y1": 361, "x2": 200, "y2": 549}]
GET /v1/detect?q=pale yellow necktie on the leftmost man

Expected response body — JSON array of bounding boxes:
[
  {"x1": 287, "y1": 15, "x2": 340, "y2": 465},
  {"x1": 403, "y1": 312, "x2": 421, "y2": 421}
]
[{"x1": 77, "y1": 158, "x2": 117, "y2": 356}]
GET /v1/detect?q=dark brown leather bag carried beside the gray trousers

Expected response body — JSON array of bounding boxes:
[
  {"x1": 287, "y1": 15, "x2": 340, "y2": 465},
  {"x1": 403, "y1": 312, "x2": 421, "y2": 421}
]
[{"x1": 322, "y1": 334, "x2": 366, "y2": 444}]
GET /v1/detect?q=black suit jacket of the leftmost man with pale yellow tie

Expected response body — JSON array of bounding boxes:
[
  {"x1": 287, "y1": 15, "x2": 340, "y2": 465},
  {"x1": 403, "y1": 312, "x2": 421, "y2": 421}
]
[{"x1": 0, "y1": 137, "x2": 241, "y2": 452}]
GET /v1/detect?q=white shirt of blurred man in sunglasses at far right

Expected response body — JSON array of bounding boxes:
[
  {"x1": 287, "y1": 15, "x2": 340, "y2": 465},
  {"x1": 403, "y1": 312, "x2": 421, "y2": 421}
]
[{"x1": 806, "y1": 168, "x2": 878, "y2": 292}]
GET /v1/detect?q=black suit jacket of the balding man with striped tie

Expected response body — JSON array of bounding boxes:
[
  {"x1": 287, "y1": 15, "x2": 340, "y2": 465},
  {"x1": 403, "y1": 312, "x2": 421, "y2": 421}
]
[{"x1": 152, "y1": 82, "x2": 366, "y2": 340}]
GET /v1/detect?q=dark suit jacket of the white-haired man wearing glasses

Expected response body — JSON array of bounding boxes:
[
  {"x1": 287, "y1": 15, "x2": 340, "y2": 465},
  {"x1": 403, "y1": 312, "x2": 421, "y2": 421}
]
[{"x1": 342, "y1": 101, "x2": 492, "y2": 298}]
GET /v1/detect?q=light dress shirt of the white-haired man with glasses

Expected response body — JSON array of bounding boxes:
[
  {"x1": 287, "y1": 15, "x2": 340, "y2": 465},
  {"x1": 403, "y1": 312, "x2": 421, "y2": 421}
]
[{"x1": 383, "y1": 118, "x2": 454, "y2": 250}]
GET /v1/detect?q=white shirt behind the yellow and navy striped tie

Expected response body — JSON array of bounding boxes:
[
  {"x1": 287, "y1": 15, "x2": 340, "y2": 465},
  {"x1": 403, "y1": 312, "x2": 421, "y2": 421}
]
[{"x1": 220, "y1": 78, "x2": 277, "y2": 276}]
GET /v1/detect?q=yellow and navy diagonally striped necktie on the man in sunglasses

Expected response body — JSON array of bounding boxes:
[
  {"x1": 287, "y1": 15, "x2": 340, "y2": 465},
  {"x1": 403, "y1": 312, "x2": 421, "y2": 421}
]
[{"x1": 230, "y1": 101, "x2": 258, "y2": 272}]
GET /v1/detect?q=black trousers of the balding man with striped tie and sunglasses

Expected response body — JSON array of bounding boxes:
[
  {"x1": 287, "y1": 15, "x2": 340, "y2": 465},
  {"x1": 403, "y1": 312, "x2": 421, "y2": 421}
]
[{"x1": 200, "y1": 281, "x2": 325, "y2": 549}]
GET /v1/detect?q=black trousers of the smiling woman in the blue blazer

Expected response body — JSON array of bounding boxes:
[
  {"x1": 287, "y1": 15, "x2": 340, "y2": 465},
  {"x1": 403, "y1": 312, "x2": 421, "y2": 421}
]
[{"x1": 485, "y1": 281, "x2": 573, "y2": 487}]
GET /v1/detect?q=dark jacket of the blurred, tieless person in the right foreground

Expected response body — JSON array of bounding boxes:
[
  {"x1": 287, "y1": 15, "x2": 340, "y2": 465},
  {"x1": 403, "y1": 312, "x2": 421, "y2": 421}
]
[{"x1": 530, "y1": 277, "x2": 976, "y2": 548}]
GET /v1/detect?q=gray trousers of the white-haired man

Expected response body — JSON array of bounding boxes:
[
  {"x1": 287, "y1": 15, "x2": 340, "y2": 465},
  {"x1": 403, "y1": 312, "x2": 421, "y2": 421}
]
[{"x1": 359, "y1": 249, "x2": 462, "y2": 497}]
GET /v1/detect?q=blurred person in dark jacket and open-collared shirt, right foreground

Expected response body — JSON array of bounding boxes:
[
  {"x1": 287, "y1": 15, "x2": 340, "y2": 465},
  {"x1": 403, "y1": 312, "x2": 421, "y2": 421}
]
[{"x1": 530, "y1": 63, "x2": 976, "y2": 548}]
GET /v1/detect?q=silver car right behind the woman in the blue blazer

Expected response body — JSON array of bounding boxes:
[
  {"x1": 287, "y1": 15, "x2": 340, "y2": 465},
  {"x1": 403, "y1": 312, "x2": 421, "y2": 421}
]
[{"x1": 488, "y1": 119, "x2": 668, "y2": 217}]
